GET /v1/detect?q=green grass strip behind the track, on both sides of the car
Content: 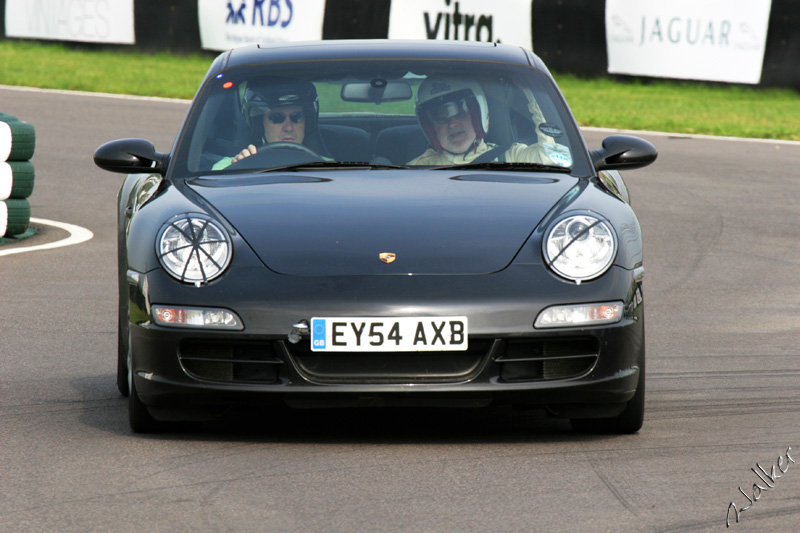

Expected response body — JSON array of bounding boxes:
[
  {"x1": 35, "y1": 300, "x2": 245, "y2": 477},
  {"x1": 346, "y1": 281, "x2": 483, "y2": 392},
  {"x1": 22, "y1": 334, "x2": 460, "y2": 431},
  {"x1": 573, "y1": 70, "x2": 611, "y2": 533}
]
[{"x1": 0, "y1": 41, "x2": 800, "y2": 141}]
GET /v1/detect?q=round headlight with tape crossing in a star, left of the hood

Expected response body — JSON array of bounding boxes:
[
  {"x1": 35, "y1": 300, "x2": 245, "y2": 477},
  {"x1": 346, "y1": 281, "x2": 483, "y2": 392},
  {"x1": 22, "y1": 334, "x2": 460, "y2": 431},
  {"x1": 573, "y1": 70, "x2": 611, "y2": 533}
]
[{"x1": 156, "y1": 214, "x2": 231, "y2": 284}]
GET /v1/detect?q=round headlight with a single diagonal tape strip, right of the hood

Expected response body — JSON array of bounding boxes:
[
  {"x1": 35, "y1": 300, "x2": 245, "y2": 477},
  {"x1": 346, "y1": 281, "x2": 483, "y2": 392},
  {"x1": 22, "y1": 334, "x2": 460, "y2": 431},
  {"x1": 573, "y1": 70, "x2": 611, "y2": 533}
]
[{"x1": 544, "y1": 214, "x2": 617, "y2": 283}]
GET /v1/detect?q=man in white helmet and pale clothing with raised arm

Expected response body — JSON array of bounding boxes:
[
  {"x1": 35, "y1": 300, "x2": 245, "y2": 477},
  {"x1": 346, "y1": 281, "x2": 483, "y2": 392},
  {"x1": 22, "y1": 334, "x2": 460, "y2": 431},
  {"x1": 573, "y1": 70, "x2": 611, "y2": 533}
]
[{"x1": 408, "y1": 78, "x2": 572, "y2": 167}]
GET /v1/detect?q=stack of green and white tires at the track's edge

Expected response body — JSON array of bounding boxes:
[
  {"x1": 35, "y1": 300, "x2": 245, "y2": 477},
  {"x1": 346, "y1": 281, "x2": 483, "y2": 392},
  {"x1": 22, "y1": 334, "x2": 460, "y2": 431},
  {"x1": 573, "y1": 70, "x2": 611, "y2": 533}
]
[{"x1": 0, "y1": 113, "x2": 36, "y2": 238}]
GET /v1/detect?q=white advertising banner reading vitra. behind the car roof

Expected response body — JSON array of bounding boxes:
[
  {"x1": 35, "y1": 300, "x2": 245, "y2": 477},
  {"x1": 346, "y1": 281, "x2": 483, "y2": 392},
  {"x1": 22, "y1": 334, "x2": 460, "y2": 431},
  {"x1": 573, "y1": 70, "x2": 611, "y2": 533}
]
[{"x1": 389, "y1": 0, "x2": 533, "y2": 49}]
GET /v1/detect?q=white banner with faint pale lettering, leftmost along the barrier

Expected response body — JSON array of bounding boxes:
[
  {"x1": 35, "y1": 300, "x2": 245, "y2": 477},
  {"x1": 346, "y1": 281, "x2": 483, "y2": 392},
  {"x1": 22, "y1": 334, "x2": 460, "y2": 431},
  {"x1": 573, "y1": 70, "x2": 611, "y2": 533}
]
[{"x1": 5, "y1": 0, "x2": 135, "y2": 44}]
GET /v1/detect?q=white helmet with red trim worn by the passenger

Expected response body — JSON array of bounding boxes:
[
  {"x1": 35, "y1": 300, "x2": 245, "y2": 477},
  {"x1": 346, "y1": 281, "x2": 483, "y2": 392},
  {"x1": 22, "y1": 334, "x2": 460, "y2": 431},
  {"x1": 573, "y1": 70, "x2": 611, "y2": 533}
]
[{"x1": 416, "y1": 78, "x2": 489, "y2": 152}]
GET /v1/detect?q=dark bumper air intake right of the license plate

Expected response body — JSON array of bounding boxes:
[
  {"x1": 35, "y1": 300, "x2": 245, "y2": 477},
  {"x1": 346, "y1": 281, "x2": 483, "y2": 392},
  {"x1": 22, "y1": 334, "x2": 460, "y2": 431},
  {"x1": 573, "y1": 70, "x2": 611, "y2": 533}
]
[{"x1": 495, "y1": 339, "x2": 598, "y2": 382}]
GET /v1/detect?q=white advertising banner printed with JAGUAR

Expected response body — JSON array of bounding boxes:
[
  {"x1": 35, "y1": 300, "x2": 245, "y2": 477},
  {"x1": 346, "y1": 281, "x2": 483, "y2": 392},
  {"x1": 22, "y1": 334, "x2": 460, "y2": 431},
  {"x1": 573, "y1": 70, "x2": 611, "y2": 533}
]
[{"x1": 606, "y1": 0, "x2": 771, "y2": 84}]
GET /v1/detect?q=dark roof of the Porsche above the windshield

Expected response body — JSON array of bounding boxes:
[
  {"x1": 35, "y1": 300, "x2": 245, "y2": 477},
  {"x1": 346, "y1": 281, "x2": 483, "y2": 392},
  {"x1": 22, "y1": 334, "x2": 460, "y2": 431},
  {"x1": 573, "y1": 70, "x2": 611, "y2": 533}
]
[{"x1": 218, "y1": 39, "x2": 546, "y2": 71}]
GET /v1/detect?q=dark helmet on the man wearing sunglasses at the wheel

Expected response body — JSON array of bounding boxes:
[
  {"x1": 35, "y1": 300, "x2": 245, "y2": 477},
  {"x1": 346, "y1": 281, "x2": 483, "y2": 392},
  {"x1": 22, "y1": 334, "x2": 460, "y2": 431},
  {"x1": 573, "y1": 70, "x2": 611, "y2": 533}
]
[{"x1": 242, "y1": 80, "x2": 319, "y2": 134}]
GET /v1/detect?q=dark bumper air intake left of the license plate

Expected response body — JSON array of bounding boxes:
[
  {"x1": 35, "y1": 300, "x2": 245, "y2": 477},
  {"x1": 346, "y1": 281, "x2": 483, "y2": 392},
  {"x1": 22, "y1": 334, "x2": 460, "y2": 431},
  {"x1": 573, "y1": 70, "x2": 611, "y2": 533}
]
[{"x1": 178, "y1": 339, "x2": 282, "y2": 383}]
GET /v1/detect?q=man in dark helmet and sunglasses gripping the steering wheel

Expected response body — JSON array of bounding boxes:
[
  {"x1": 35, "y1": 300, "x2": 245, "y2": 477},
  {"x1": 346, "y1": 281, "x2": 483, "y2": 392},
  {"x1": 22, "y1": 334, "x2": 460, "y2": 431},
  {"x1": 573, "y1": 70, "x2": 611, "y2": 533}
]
[{"x1": 212, "y1": 82, "x2": 319, "y2": 170}]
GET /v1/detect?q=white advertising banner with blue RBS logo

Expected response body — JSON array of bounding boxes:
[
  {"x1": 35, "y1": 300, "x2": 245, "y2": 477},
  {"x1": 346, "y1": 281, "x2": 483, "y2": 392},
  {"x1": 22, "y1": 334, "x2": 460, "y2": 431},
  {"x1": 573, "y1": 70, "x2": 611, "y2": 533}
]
[{"x1": 197, "y1": 0, "x2": 325, "y2": 51}]
